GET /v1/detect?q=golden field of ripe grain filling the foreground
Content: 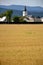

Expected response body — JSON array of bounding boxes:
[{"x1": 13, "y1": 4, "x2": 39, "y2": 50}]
[{"x1": 0, "y1": 24, "x2": 43, "y2": 65}]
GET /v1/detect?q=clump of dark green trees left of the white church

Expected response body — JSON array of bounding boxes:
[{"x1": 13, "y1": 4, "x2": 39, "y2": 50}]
[{"x1": 0, "y1": 10, "x2": 26, "y2": 23}]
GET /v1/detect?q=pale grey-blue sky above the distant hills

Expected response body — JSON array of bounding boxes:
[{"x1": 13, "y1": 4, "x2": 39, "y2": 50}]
[{"x1": 0, "y1": 0, "x2": 43, "y2": 7}]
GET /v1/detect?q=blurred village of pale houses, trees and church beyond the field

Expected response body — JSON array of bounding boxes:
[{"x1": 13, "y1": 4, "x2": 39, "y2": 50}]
[{"x1": 0, "y1": 6, "x2": 43, "y2": 23}]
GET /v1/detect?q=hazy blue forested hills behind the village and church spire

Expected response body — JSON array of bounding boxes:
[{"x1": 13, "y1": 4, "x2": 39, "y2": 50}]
[{"x1": 0, "y1": 5, "x2": 43, "y2": 17}]
